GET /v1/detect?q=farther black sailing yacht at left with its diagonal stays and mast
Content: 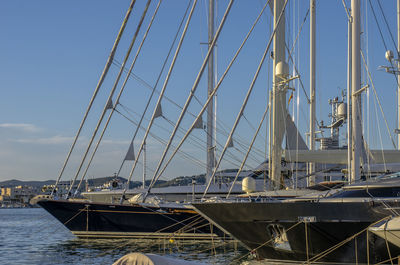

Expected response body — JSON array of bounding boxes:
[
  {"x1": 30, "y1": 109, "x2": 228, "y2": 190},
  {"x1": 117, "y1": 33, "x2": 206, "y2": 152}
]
[{"x1": 34, "y1": 0, "x2": 278, "y2": 240}]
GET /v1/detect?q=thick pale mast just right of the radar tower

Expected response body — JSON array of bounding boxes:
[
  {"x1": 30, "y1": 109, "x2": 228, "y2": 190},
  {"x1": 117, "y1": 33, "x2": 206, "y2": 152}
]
[{"x1": 351, "y1": 0, "x2": 362, "y2": 182}]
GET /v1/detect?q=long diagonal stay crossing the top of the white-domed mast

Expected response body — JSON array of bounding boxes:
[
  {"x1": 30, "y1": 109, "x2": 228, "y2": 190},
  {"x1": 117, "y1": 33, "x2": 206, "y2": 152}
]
[{"x1": 203, "y1": 0, "x2": 288, "y2": 198}]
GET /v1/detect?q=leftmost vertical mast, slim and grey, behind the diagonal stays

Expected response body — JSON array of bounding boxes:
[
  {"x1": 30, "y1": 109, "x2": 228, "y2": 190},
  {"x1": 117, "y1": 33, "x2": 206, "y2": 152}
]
[{"x1": 206, "y1": 0, "x2": 215, "y2": 183}]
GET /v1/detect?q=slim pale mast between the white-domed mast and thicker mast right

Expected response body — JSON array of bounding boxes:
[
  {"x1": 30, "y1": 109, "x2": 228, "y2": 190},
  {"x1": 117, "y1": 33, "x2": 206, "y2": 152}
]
[{"x1": 308, "y1": 0, "x2": 316, "y2": 186}]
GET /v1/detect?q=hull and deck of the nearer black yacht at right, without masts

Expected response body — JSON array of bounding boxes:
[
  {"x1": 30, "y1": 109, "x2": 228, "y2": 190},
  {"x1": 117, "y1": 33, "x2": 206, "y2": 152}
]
[{"x1": 194, "y1": 174, "x2": 400, "y2": 263}]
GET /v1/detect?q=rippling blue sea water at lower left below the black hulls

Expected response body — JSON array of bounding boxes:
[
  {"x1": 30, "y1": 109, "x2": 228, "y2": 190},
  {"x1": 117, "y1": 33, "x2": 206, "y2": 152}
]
[{"x1": 0, "y1": 208, "x2": 255, "y2": 265}]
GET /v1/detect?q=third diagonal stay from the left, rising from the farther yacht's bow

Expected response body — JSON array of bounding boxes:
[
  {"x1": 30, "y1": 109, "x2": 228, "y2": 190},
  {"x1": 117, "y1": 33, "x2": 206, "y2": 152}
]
[{"x1": 76, "y1": 0, "x2": 156, "y2": 192}]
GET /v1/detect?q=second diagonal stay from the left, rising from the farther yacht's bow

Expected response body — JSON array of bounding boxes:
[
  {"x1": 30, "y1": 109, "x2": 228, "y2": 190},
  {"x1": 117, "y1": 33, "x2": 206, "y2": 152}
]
[{"x1": 66, "y1": 0, "x2": 151, "y2": 198}]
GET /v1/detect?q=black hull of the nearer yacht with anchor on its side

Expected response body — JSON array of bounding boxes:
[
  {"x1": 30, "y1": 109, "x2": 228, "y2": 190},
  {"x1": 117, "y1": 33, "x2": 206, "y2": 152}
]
[{"x1": 195, "y1": 199, "x2": 400, "y2": 263}]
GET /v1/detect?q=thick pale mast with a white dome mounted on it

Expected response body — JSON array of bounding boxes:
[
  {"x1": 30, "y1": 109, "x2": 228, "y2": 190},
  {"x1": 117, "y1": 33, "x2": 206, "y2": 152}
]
[{"x1": 269, "y1": 0, "x2": 289, "y2": 190}]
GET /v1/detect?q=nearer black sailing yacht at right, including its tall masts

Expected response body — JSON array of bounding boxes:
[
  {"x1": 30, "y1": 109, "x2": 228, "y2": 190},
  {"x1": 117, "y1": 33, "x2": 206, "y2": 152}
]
[{"x1": 194, "y1": 0, "x2": 400, "y2": 264}]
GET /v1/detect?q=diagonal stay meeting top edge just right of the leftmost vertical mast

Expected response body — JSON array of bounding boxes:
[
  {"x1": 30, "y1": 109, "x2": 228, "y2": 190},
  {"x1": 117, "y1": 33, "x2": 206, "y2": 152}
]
[{"x1": 145, "y1": 0, "x2": 234, "y2": 190}]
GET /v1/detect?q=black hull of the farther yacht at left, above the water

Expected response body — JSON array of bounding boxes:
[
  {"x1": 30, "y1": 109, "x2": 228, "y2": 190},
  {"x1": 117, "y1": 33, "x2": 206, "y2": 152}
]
[{"x1": 38, "y1": 200, "x2": 220, "y2": 239}]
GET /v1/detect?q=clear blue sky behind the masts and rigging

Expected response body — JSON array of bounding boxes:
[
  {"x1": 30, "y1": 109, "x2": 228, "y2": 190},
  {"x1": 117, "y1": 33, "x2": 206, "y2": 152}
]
[{"x1": 0, "y1": 0, "x2": 397, "y2": 180}]
